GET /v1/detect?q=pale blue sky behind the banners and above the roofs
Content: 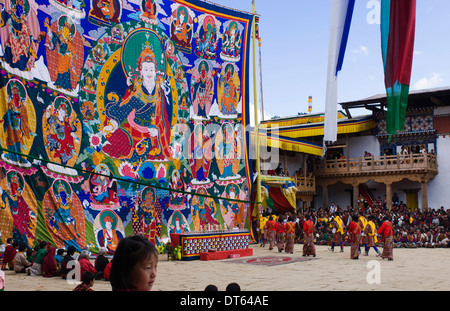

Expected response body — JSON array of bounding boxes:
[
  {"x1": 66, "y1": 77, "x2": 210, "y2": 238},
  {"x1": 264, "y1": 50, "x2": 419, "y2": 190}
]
[{"x1": 212, "y1": 0, "x2": 450, "y2": 121}]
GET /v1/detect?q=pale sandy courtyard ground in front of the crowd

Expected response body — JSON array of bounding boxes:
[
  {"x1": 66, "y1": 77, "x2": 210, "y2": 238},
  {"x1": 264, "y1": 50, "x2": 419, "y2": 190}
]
[{"x1": 5, "y1": 244, "x2": 450, "y2": 292}]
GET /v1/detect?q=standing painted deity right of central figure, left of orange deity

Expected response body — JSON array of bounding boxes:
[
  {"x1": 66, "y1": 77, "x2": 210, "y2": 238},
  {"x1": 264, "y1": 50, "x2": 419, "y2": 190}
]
[{"x1": 191, "y1": 61, "x2": 214, "y2": 119}]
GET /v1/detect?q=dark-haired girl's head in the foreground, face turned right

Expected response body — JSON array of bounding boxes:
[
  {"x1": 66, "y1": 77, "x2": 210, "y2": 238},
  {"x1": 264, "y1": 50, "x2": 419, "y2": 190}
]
[{"x1": 110, "y1": 235, "x2": 158, "y2": 291}]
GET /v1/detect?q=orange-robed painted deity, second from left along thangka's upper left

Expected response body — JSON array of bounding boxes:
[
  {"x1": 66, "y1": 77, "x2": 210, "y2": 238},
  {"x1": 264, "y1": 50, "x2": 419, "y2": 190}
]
[{"x1": 44, "y1": 16, "x2": 82, "y2": 91}]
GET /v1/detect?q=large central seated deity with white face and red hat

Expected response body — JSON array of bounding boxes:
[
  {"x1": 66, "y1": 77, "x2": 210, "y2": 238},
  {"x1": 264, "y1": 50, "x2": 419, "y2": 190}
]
[{"x1": 103, "y1": 45, "x2": 171, "y2": 160}]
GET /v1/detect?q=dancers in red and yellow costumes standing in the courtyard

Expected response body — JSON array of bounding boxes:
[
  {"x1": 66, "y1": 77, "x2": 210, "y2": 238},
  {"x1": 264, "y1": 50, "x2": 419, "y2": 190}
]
[{"x1": 258, "y1": 211, "x2": 394, "y2": 260}]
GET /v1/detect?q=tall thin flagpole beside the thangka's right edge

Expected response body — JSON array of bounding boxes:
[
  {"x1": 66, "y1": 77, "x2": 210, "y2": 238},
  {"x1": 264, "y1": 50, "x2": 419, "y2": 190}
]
[{"x1": 252, "y1": 0, "x2": 261, "y2": 214}]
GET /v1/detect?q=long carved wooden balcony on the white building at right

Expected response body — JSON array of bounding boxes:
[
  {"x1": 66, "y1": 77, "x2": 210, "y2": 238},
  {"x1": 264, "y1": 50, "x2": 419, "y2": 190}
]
[{"x1": 314, "y1": 153, "x2": 438, "y2": 178}]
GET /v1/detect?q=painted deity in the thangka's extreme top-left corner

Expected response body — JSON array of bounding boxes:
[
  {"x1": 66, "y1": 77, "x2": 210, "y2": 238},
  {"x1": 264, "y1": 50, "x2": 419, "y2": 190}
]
[{"x1": 0, "y1": 0, "x2": 41, "y2": 71}]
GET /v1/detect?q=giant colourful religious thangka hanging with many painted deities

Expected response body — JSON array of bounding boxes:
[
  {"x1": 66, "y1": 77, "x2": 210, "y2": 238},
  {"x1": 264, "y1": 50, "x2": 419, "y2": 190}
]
[{"x1": 0, "y1": 0, "x2": 252, "y2": 253}]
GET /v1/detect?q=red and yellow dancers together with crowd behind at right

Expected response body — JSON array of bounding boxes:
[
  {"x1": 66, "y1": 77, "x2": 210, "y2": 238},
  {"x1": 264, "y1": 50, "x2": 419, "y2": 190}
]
[{"x1": 257, "y1": 202, "x2": 450, "y2": 260}]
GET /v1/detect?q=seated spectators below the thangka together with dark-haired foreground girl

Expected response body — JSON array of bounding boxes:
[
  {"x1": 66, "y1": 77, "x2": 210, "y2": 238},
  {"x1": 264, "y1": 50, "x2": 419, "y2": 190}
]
[{"x1": 0, "y1": 235, "x2": 158, "y2": 291}]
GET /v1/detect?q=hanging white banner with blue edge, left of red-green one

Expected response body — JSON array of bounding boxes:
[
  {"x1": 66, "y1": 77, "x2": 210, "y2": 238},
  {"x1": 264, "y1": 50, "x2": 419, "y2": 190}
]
[{"x1": 323, "y1": 0, "x2": 355, "y2": 146}]
